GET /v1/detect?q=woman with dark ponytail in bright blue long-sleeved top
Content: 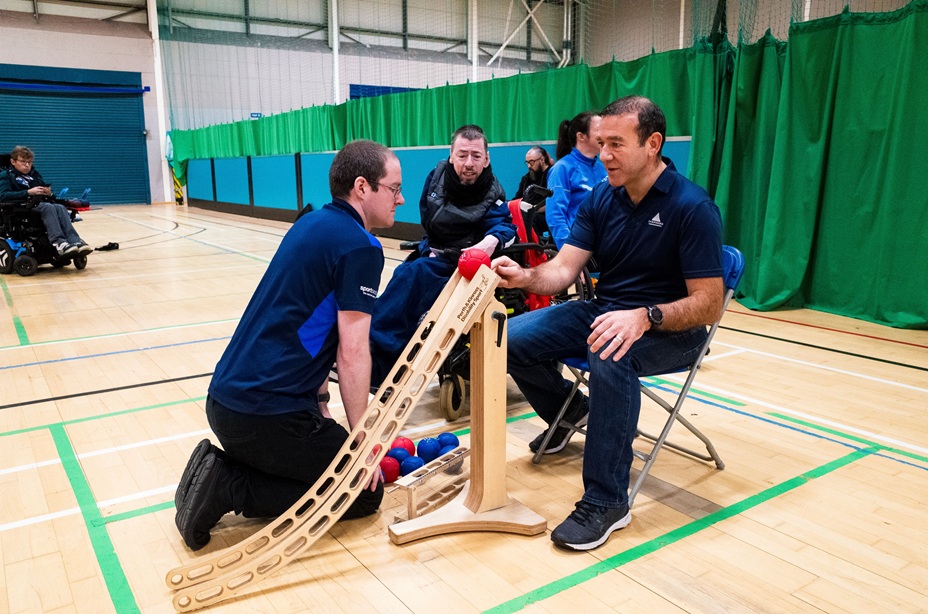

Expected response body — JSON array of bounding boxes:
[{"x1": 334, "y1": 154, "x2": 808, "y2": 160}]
[{"x1": 545, "y1": 111, "x2": 606, "y2": 249}]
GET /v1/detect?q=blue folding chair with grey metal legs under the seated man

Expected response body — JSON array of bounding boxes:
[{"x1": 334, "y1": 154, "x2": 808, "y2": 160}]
[{"x1": 532, "y1": 245, "x2": 744, "y2": 507}]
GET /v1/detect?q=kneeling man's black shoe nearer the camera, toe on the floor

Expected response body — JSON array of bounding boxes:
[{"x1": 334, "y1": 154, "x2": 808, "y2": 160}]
[{"x1": 174, "y1": 452, "x2": 232, "y2": 550}]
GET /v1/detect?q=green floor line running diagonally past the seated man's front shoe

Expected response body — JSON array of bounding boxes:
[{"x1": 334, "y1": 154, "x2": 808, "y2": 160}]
[{"x1": 484, "y1": 448, "x2": 879, "y2": 614}]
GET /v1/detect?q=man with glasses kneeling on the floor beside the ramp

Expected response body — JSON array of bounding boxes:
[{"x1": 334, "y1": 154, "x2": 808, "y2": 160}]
[{"x1": 174, "y1": 141, "x2": 403, "y2": 550}]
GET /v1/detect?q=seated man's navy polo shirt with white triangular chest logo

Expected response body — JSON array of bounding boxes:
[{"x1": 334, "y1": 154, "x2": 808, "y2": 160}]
[{"x1": 567, "y1": 158, "x2": 722, "y2": 309}]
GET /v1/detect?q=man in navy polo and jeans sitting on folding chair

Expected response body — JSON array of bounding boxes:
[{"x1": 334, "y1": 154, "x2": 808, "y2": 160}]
[{"x1": 492, "y1": 96, "x2": 724, "y2": 550}]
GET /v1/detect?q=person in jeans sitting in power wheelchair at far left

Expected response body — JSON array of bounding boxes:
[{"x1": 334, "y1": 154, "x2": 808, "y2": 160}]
[{"x1": 0, "y1": 146, "x2": 93, "y2": 256}]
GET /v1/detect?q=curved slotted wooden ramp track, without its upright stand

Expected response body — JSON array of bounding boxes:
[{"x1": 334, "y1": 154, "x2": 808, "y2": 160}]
[{"x1": 165, "y1": 266, "x2": 544, "y2": 612}]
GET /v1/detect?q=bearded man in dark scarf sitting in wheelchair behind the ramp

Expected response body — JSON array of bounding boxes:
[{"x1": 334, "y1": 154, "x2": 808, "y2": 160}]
[{"x1": 371, "y1": 125, "x2": 516, "y2": 385}]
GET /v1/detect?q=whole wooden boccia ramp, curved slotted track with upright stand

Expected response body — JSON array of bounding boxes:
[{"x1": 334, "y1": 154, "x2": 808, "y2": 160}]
[{"x1": 165, "y1": 266, "x2": 547, "y2": 612}]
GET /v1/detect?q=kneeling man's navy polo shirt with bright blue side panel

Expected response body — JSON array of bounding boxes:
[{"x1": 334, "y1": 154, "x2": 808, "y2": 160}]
[{"x1": 209, "y1": 199, "x2": 384, "y2": 415}]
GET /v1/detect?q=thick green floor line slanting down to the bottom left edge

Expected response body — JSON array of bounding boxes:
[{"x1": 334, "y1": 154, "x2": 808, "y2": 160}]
[{"x1": 49, "y1": 425, "x2": 141, "y2": 614}]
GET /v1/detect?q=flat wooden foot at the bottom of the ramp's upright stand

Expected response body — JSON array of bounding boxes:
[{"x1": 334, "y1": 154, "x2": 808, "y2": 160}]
[{"x1": 389, "y1": 483, "x2": 548, "y2": 545}]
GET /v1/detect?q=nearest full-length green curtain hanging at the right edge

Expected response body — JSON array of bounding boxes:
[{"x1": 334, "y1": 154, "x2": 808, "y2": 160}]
[{"x1": 743, "y1": 0, "x2": 928, "y2": 328}]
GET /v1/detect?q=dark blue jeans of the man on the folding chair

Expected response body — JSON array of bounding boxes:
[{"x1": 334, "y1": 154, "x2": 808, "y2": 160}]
[{"x1": 508, "y1": 301, "x2": 707, "y2": 507}]
